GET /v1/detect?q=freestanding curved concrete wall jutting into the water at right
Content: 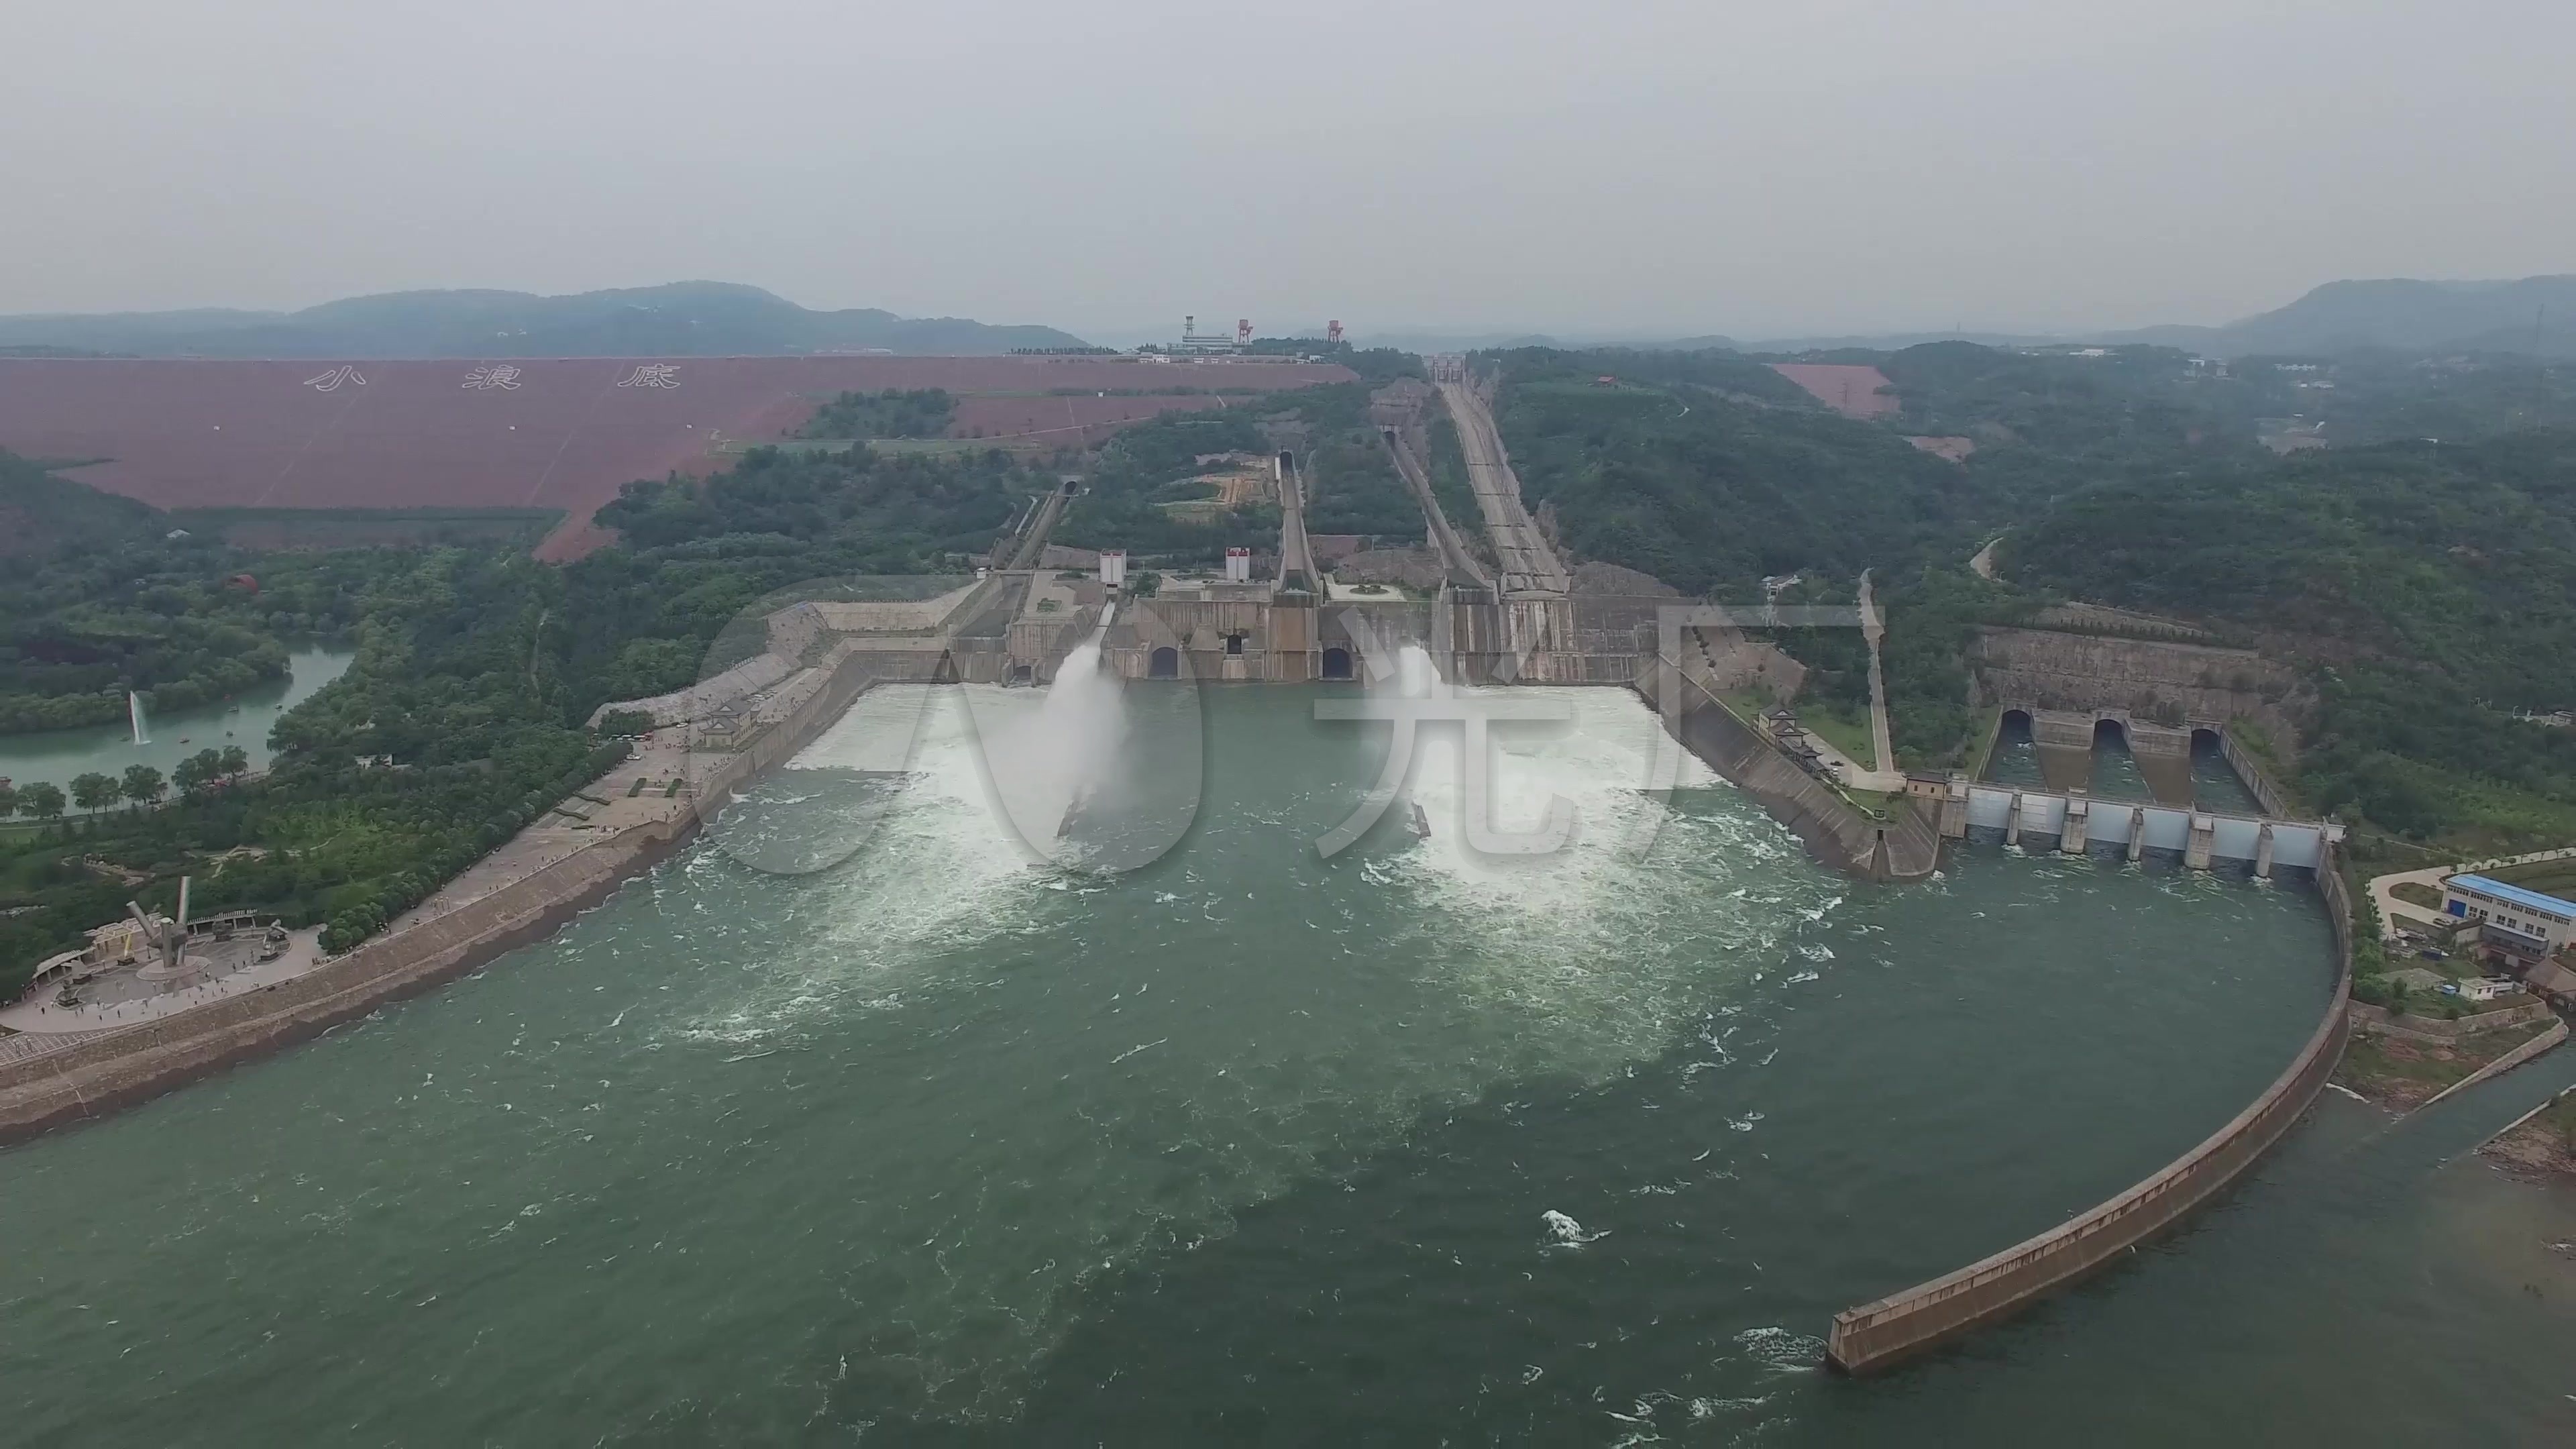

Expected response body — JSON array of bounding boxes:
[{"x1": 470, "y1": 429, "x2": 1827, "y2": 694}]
[{"x1": 1824, "y1": 846, "x2": 2352, "y2": 1375}]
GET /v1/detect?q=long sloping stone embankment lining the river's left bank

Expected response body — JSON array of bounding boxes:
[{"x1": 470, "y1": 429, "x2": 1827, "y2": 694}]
[{"x1": 0, "y1": 631, "x2": 912, "y2": 1142}]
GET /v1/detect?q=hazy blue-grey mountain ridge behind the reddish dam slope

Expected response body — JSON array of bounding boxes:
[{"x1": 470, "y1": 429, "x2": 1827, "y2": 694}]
[{"x1": 0, "y1": 281, "x2": 1082, "y2": 358}]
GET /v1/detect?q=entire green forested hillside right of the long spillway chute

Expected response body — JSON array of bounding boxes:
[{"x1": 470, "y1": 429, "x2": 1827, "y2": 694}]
[{"x1": 1479, "y1": 343, "x2": 2576, "y2": 851}]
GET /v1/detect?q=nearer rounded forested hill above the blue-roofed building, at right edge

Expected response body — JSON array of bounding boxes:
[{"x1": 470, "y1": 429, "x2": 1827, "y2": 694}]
[{"x1": 2002, "y1": 431, "x2": 2576, "y2": 843}]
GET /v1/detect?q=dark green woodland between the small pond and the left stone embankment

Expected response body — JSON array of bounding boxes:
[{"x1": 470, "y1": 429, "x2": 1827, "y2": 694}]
[{"x1": 0, "y1": 438, "x2": 1051, "y2": 979}]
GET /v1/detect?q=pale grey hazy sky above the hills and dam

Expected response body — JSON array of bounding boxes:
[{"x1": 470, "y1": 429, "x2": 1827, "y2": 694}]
[{"x1": 15, "y1": 0, "x2": 2576, "y2": 337}]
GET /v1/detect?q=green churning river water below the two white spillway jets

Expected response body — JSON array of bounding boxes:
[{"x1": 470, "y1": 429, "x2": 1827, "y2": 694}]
[{"x1": 0, "y1": 686, "x2": 2576, "y2": 1446}]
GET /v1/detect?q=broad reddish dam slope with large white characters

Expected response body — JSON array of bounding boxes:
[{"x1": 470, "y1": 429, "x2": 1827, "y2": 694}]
[{"x1": 0, "y1": 356, "x2": 1352, "y2": 559}]
